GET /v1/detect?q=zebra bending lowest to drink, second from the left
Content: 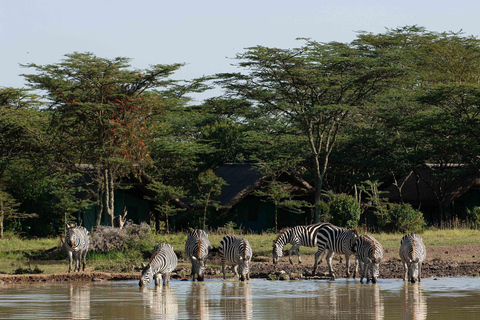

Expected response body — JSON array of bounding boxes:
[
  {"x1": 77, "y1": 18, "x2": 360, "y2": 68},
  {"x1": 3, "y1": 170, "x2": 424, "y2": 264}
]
[{"x1": 138, "y1": 243, "x2": 178, "y2": 287}]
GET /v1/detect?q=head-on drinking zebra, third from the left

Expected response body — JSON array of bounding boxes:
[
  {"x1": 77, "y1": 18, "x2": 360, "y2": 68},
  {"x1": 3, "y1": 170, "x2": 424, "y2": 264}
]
[{"x1": 185, "y1": 229, "x2": 212, "y2": 281}]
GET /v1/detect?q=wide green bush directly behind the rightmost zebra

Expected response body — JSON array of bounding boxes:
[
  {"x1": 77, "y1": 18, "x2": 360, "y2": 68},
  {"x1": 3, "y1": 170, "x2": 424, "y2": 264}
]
[{"x1": 377, "y1": 203, "x2": 425, "y2": 234}]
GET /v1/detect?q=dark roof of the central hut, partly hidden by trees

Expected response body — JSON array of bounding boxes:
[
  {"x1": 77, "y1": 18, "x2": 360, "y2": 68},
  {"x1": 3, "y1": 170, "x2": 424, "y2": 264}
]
[{"x1": 215, "y1": 163, "x2": 314, "y2": 207}]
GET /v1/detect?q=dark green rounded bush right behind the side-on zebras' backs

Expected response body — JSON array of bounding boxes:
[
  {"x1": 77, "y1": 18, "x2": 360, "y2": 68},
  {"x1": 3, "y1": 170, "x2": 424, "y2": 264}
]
[{"x1": 328, "y1": 193, "x2": 362, "y2": 229}]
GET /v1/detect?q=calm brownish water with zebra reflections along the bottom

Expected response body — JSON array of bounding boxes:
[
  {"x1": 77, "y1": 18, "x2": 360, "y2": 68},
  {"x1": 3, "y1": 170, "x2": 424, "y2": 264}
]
[{"x1": 0, "y1": 278, "x2": 480, "y2": 320}]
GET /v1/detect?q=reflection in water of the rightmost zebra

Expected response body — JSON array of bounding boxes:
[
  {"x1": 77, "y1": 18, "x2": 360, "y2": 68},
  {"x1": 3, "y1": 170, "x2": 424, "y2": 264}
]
[{"x1": 402, "y1": 283, "x2": 427, "y2": 320}]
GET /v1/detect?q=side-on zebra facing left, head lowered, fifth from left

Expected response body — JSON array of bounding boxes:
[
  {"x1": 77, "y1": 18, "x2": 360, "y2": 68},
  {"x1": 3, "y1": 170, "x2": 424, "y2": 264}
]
[{"x1": 272, "y1": 223, "x2": 327, "y2": 264}]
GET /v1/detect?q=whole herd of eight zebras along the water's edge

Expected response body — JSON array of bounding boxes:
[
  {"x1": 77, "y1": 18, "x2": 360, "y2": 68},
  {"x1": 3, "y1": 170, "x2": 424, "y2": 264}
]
[{"x1": 65, "y1": 223, "x2": 426, "y2": 287}]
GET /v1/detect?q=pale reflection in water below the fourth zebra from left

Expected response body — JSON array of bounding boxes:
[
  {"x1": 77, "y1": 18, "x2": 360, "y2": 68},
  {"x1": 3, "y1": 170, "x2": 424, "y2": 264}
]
[{"x1": 220, "y1": 281, "x2": 253, "y2": 319}]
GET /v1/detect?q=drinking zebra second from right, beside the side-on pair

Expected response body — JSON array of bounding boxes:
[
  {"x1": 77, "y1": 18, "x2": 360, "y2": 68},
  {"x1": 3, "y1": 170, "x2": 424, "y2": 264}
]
[{"x1": 353, "y1": 234, "x2": 383, "y2": 283}]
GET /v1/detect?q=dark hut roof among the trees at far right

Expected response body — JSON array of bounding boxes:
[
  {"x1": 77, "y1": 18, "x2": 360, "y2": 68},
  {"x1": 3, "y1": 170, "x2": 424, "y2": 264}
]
[{"x1": 385, "y1": 165, "x2": 480, "y2": 206}]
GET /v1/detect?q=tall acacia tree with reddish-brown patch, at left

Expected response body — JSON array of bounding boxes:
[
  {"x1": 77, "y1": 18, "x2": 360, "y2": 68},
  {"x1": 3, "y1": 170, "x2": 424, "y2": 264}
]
[{"x1": 24, "y1": 52, "x2": 189, "y2": 225}]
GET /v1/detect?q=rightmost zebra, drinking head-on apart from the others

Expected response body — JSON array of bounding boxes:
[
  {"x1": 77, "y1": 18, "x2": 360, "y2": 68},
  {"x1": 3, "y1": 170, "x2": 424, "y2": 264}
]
[{"x1": 400, "y1": 233, "x2": 427, "y2": 283}]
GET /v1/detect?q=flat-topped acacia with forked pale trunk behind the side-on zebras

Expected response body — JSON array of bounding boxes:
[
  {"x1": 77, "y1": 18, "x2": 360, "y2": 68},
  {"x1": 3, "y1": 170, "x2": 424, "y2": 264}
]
[{"x1": 218, "y1": 40, "x2": 400, "y2": 221}]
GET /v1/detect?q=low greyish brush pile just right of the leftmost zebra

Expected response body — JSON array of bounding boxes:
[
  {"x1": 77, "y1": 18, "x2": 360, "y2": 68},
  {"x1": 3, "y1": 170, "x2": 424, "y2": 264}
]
[{"x1": 90, "y1": 222, "x2": 153, "y2": 253}]
